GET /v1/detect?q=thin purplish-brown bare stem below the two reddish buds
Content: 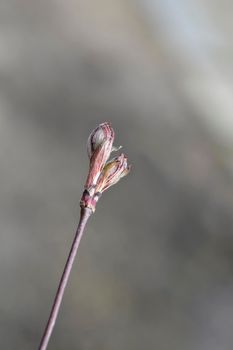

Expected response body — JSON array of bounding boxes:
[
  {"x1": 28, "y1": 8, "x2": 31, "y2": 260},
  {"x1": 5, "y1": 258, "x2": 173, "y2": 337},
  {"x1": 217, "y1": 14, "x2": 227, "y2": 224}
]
[{"x1": 39, "y1": 208, "x2": 92, "y2": 350}]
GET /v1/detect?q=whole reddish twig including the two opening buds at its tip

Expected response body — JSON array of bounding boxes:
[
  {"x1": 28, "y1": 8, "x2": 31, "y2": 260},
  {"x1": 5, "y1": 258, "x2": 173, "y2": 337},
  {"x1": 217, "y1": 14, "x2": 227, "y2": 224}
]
[{"x1": 39, "y1": 122, "x2": 130, "y2": 350}]
